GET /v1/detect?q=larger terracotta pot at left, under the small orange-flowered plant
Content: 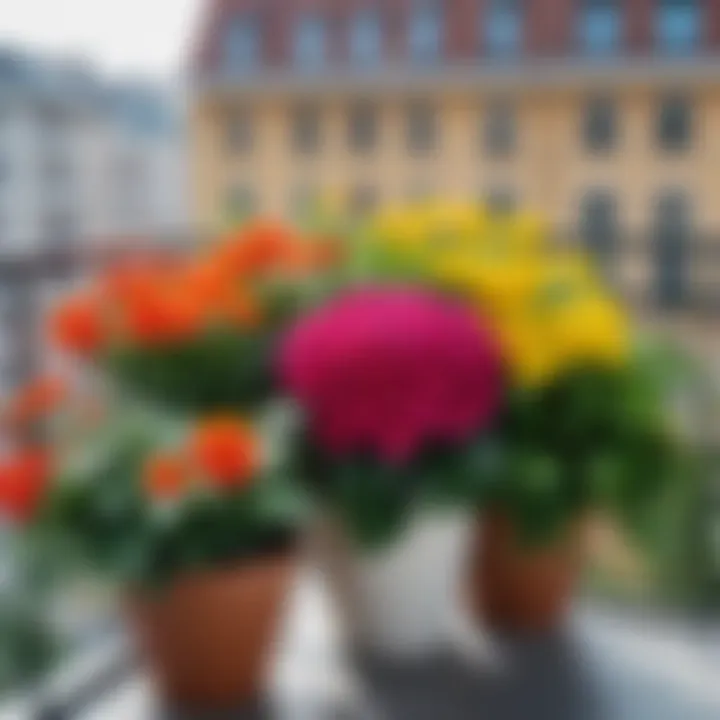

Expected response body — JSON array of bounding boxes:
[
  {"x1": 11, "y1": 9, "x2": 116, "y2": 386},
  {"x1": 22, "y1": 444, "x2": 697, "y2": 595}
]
[{"x1": 128, "y1": 555, "x2": 296, "y2": 710}]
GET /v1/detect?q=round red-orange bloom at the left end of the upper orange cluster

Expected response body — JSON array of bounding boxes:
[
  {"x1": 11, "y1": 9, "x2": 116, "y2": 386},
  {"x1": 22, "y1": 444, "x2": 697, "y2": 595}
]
[{"x1": 49, "y1": 293, "x2": 105, "y2": 355}]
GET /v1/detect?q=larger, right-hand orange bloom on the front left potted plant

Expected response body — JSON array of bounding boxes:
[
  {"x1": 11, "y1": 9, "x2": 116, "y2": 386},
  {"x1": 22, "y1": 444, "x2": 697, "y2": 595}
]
[{"x1": 190, "y1": 417, "x2": 259, "y2": 488}]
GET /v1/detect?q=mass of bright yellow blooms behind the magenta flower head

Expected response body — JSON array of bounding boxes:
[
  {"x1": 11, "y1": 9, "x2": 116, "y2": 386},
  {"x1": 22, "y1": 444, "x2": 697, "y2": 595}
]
[{"x1": 374, "y1": 203, "x2": 629, "y2": 385}]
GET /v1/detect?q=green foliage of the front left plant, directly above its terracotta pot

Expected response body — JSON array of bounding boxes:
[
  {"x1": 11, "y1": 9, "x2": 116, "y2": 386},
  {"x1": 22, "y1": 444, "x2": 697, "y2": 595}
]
[{"x1": 38, "y1": 422, "x2": 305, "y2": 587}]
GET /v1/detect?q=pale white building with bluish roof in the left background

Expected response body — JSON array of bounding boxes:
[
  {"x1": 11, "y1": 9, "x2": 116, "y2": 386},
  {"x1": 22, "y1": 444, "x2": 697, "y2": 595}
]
[{"x1": 0, "y1": 48, "x2": 188, "y2": 403}]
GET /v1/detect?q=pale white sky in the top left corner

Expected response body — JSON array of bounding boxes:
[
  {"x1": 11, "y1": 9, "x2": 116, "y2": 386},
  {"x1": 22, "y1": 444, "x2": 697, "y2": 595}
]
[{"x1": 0, "y1": 0, "x2": 204, "y2": 78}]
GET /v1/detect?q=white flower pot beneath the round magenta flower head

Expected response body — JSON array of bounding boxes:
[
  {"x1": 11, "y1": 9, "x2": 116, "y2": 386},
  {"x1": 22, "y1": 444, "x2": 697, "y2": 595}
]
[{"x1": 315, "y1": 512, "x2": 473, "y2": 658}]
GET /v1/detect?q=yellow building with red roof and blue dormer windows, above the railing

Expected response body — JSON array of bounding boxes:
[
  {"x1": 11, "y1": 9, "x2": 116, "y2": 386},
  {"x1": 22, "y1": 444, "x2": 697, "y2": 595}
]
[{"x1": 190, "y1": 0, "x2": 720, "y2": 242}]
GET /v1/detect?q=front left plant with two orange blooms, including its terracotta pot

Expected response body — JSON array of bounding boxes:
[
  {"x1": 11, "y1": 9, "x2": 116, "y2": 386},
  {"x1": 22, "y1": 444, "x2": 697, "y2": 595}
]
[{"x1": 37, "y1": 415, "x2": 302, "y2": 710}]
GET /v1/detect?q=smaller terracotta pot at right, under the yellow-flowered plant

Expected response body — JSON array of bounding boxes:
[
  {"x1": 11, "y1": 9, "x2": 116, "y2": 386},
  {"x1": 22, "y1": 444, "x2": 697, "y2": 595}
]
[{"x1": 469, "y1": 513, "x2": 583, "y2": 632}]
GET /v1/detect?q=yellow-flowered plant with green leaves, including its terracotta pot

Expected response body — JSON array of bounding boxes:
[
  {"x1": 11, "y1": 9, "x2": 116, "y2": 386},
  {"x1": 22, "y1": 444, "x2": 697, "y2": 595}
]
[{"x1": 362, "y1": 200, "x2": 696, "y2": 629}]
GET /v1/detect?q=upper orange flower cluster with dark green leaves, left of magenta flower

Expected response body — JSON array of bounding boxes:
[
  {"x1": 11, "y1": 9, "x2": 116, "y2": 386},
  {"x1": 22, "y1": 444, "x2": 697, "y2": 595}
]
[{"x1": 50, "y1": 220, "x2": 332, "y2": 412}]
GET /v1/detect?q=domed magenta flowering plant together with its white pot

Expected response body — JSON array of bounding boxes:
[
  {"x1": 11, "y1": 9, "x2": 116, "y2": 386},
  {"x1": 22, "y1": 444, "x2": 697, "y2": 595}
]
[{"x1": 280, "y1": 286, "x2": 503, "y2": 654}]
